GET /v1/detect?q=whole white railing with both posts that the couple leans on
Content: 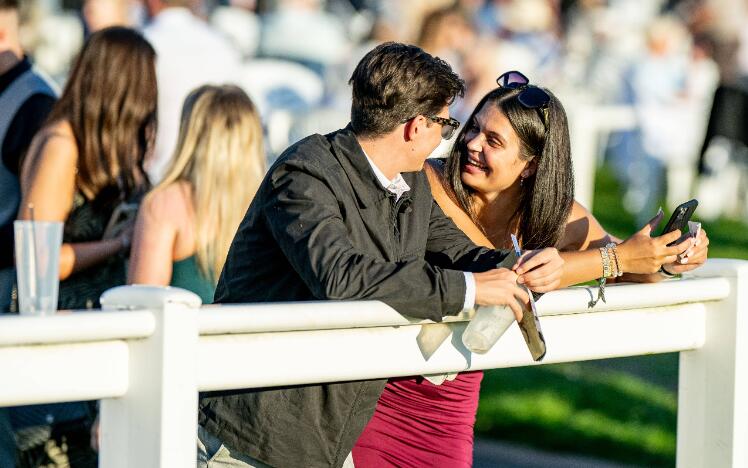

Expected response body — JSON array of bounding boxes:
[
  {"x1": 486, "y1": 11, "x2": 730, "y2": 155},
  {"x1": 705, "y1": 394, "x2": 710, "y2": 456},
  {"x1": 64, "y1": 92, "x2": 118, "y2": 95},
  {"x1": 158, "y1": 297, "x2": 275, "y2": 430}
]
[{"x1": 0, "y1": 259, "x2": 748, "y2": 468}]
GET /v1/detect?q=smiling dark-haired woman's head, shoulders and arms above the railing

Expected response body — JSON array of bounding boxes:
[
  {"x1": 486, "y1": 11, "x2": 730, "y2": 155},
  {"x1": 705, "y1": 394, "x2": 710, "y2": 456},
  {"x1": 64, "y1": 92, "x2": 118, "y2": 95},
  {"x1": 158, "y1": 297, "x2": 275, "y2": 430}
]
[{"x1": 427, "y1": 72, "x2": 708, "y2": 287}]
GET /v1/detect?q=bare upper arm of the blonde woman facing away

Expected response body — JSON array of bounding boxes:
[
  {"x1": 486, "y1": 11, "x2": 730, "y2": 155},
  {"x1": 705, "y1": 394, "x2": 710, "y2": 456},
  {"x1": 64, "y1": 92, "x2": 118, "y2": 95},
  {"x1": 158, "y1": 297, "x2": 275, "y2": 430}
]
[{"x1": 127, "y1": 188, "x2": 177, "y2": 286}]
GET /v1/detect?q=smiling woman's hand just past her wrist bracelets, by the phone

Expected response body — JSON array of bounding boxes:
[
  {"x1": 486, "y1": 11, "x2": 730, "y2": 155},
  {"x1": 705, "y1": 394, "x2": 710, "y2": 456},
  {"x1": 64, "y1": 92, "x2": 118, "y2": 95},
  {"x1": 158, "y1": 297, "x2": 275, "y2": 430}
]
[{"x1": 616, "y1": 213, "x2": 693, "y2": 274}]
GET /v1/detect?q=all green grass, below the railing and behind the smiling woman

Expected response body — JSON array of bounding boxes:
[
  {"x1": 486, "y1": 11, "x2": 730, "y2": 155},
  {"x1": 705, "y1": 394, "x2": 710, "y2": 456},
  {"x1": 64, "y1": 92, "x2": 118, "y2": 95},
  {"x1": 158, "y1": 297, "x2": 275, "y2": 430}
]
[{"x1": 475, "y1": 169, "x2": 748, "y2": 466}]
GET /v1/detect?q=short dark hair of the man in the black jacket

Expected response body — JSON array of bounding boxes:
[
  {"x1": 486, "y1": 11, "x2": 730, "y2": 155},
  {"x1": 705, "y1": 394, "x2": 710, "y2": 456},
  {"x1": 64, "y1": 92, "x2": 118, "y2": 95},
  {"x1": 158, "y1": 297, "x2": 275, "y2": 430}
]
[{"x1": 348, "y1": 42, "x2": 465, "y2": 137}]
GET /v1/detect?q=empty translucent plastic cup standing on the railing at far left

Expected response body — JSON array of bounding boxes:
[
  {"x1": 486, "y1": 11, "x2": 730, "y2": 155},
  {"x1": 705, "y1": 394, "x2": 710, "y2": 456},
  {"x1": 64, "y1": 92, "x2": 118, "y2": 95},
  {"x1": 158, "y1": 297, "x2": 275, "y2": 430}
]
[{"x1": 13, "y1": 221, "x2": 63, "y2": 315}]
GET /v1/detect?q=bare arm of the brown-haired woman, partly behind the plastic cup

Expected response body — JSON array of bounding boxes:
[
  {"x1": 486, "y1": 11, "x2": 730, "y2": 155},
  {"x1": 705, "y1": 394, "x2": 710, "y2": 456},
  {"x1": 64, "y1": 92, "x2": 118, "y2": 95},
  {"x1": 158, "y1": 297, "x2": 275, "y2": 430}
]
[{"x1": 18, "y1": 124, "x2": 127, "y2": 279}]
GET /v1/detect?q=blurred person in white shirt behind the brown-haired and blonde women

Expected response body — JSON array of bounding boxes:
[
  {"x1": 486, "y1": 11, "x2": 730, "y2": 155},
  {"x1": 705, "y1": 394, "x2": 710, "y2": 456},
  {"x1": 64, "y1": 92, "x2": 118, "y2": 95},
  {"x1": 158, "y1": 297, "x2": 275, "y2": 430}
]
[{"x1": 143, "y1": 0, "x2": 240, "y2": 183}]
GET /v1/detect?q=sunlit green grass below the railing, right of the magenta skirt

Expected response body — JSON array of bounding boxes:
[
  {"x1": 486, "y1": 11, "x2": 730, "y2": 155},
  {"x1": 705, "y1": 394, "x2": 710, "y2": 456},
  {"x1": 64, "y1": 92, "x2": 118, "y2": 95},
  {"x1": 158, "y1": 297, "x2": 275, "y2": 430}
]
[{"x1": 476, "y1": 363, "x2": 677, "y2": 466}]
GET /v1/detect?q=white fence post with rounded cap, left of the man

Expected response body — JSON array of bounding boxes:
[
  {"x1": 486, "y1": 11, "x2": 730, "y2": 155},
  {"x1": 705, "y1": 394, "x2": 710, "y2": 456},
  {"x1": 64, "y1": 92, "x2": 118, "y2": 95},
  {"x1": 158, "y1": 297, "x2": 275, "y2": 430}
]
[{"x1": 100, "y1": 286, "x2": 200, "y2": 468}]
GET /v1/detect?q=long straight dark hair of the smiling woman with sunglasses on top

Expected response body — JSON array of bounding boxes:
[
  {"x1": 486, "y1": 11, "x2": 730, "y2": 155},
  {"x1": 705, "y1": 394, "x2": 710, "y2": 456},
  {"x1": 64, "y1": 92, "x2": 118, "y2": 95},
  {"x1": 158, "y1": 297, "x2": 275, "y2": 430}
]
[{"x1": 445, "y1": 88, "x2": 574, "y2": 249}]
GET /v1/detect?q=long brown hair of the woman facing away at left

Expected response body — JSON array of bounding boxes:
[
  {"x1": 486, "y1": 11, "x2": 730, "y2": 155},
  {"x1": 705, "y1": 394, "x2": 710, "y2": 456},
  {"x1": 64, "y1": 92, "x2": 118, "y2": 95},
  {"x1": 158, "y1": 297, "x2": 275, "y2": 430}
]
[{"x1": 47, "y1": 27, "x2": 157, "y2": 199}]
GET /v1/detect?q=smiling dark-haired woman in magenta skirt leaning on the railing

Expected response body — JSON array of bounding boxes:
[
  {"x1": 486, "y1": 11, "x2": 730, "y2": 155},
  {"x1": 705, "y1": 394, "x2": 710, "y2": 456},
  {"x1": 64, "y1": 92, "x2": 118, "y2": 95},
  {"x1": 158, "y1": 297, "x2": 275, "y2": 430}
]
[{"x1": 353, "y1": 72, "x2": 708, "y2": 468}]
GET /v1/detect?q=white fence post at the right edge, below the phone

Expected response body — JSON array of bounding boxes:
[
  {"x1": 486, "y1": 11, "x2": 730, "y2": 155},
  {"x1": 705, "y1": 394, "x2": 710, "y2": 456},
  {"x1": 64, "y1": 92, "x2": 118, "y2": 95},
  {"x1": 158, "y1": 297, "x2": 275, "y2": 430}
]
[{"x1": 676, "y1": 260, "x2": 748, "y2": 468}]
